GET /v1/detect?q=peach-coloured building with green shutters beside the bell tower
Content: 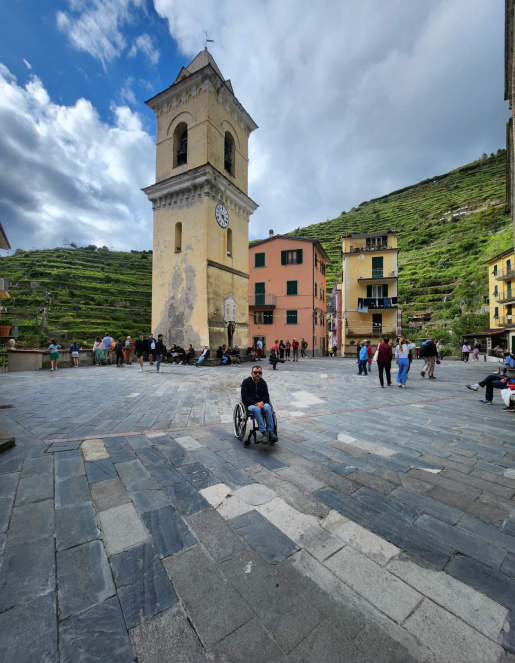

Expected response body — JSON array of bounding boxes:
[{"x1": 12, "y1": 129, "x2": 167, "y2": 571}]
[{"x1": 249, "y1": 235, "x2": 329, "y2": 357}]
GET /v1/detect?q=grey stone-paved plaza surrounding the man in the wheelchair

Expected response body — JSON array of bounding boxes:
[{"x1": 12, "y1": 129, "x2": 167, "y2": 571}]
[{"x1": 0, "y1": 358, "x2": 515, "y2": 663}]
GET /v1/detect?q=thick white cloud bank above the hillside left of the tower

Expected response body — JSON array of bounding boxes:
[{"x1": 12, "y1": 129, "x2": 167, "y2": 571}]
[{"x1": 0, "y1": 64, "x2": 154, "y2": 249}]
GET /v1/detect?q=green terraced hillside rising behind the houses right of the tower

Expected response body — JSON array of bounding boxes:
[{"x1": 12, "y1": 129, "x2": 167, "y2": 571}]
[{"x1": 292, "y1": 150, "x2": 513, "y2": 320}]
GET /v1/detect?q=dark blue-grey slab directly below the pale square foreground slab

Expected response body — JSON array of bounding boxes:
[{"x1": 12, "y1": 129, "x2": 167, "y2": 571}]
[{"x1": 111, "y1": 543, "x2": 179, "y2": 628}]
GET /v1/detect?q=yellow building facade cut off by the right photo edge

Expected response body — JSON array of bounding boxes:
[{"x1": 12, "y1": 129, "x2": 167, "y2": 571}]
[{"x1": 486, "y1": 249, "x2": 515, "y2": 352}]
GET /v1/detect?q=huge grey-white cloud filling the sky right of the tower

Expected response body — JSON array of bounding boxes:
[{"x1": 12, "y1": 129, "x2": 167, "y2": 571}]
[{"x1": 154, "y1": 0, "x2": 508, "y2": 237}]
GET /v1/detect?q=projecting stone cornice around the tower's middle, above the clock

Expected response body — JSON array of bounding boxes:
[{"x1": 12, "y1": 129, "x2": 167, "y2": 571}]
[{"x1": 142, "y1": 163, "x2": 258, "y2": 220}]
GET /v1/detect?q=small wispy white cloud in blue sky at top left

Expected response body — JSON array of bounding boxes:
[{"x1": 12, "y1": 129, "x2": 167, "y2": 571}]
[{"x1": 56, "y1": 0, "x2": 145, "y2": 70}]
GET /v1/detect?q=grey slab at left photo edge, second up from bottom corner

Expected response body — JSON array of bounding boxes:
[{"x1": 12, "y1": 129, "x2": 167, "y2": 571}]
[{"x1": 0, "y1": 536, "x2": 55, "y2": 611}]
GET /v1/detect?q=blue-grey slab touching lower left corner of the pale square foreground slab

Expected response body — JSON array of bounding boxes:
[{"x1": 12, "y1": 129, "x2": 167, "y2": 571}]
[{"x1": 57, "y1": 541, "x2": 116, "y2": 620}]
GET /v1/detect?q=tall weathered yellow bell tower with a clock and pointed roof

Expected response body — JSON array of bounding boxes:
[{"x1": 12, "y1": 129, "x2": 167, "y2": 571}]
[{"x1": 143, "y1": 48, "x2": 257, "y2": 352}]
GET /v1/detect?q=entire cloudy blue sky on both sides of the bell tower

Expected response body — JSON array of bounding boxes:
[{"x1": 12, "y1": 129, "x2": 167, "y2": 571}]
[{"x1": 0, "y1": 0, "x2": 508, "y2": 250}]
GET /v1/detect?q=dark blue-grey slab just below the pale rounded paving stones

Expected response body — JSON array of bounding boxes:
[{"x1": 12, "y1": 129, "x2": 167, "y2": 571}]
[{"x1": 229, "y1": 510, "x2": 299, "y2": 564}]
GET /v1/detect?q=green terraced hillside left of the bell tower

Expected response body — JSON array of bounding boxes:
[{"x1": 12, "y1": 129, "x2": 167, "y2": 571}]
[{"x1": 0, "y1": 248, "x2": 152, "y2": 347}]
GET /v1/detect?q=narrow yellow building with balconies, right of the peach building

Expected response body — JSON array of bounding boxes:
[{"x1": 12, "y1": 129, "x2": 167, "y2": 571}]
[{"x1": 341, "y1": 230, "x2": 400, "y2": 354}]
